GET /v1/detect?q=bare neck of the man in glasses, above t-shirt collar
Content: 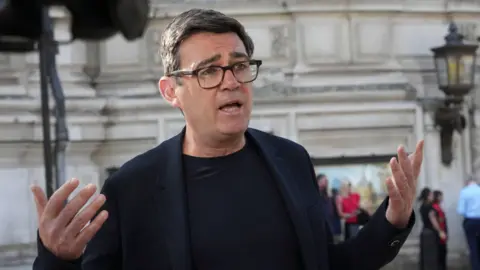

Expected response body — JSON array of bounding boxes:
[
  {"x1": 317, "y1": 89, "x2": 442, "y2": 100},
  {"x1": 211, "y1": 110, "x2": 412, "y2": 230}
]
[{"x1": 183, "y1": 127, "x2": 245, "y2": 157}]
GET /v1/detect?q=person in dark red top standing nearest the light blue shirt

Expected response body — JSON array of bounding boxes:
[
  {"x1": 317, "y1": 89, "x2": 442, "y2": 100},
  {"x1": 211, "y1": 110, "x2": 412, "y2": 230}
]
[{"x1": 432, "y1": 190, "x2": 448, "y2": 270}]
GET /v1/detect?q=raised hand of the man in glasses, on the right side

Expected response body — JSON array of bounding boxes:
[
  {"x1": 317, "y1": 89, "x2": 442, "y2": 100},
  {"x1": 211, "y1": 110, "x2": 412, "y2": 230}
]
[{"x1": 386, "y1": 140, "x2": 424, "y2": 229}]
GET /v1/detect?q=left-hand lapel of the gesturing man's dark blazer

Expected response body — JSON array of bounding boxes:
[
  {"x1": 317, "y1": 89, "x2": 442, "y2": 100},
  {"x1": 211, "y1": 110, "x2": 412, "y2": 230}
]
[{"x1": 154, "y1": 129, "x2": 192, "y2": 270}]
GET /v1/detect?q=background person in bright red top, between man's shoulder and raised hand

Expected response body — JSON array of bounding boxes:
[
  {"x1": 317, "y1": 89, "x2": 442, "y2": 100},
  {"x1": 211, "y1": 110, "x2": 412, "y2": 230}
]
[{"x1": 342, "y1": 183, "x2": 360, "y2": 240}]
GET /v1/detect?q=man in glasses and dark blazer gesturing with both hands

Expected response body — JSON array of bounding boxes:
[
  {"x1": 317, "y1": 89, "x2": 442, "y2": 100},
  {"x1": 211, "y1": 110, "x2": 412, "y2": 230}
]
[{"x1": 33, "y1": 9, "x2": 423, "y2": 270}]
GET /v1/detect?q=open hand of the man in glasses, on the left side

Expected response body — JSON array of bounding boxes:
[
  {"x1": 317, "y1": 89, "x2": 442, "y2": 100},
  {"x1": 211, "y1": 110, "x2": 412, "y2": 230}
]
[{"x1": 31, "y1": 179, "x2": 108, "y2": 260}]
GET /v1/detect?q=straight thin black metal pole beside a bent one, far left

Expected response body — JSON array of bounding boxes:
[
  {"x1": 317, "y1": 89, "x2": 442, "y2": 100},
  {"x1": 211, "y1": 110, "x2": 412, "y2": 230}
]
[{"x1": 38, "y1": 7, "x2": 55, "y2": 198}]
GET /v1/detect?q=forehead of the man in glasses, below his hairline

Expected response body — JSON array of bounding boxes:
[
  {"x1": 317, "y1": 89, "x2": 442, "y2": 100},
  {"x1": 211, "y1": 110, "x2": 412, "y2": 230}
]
[{"x1": 178, "y1": 32, "x2": 247, "y2": 67}]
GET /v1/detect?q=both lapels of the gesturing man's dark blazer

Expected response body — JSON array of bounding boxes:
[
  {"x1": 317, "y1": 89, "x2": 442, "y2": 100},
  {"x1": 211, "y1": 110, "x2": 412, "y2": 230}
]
[{"x1": 153, "y1": 126, "x2": 317, "y2": 270}]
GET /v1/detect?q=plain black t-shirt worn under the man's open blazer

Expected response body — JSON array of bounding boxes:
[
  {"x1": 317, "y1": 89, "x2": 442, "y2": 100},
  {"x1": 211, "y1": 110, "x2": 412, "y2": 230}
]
[{"x1": 183, "y1": 139, "x2": 302, "y2": 270}]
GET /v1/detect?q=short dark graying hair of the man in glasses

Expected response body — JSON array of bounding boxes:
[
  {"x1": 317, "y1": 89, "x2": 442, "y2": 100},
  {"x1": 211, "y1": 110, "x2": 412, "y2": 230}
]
[{"x1": 160, "y1": 9, "x2": 254, "y2": 74}]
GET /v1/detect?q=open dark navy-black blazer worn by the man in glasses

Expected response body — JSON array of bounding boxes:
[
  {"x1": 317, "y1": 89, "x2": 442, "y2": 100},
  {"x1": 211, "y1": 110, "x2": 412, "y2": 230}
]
[{"x1": 33, "y1": 129, "x2": 415, "y2": 270}]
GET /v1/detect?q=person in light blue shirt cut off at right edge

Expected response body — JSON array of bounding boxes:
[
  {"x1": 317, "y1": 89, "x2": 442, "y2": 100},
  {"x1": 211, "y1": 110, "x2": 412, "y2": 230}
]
[{"x1": 457, "y1": 177, "x2": 480, "y2": 270}]
